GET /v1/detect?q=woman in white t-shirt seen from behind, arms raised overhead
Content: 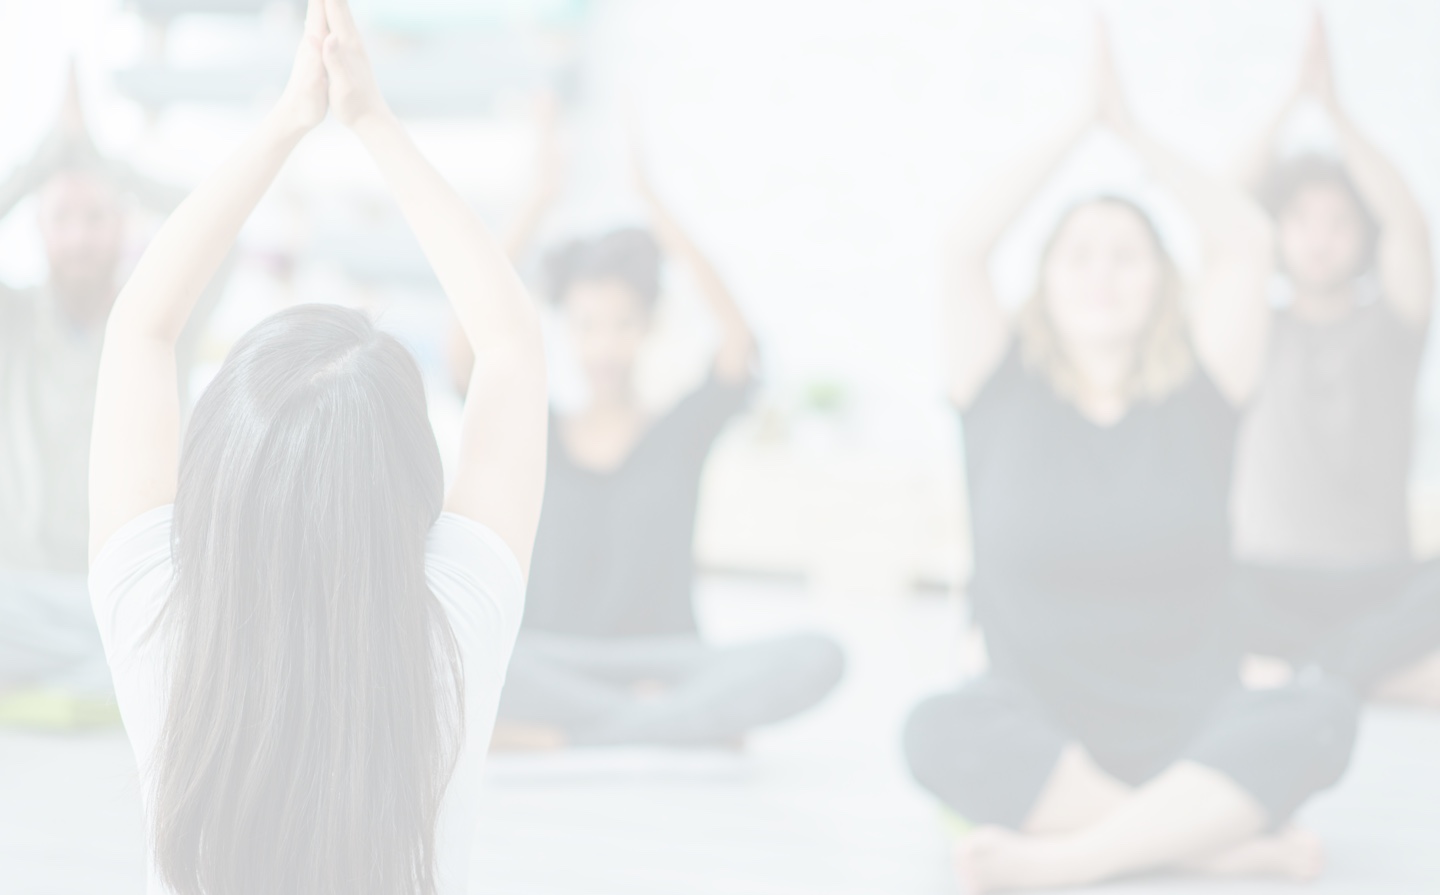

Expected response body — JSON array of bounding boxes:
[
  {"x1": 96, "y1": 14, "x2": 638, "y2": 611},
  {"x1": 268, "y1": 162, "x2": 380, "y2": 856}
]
[{"x1": 91, "y1": 0, "x2": 547, "y2": 895}]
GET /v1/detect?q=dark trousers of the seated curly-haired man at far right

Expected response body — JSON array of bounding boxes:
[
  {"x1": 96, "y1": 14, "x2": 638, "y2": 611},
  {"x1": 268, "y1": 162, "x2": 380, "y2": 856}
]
[{"x1": 1237, "y1": 560, "x2": 1440, "y2": 694}]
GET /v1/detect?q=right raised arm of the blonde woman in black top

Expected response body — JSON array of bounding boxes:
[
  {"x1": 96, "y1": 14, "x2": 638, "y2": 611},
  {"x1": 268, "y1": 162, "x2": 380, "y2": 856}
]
[{"x1": 1100, "y1": 28, "x2": 1274, "y2": 406}]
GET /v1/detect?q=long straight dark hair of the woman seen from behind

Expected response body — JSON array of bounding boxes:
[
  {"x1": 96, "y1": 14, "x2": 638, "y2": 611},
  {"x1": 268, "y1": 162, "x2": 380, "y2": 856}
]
[{"x1": 151, "y1": 305, "x2": 464, "y2": 895}]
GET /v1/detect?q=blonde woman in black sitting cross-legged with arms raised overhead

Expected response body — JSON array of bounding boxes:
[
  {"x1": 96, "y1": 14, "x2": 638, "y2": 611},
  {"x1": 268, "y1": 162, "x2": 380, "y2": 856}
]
[{"x1": 906, "y1": 24, "x2": 1355, "y2": 891}]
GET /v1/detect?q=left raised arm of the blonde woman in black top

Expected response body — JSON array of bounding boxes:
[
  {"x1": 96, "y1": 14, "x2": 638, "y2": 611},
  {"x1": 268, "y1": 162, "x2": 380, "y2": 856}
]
[{"x1": 940, "y1": 96, "x2": 1094, "y2": 409}]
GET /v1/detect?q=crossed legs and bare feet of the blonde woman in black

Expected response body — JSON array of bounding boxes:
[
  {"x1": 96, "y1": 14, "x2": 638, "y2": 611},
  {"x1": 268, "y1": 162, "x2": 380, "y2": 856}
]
[{"x1": 906, "y1": 681, "x2": 1354, "y2": 892}]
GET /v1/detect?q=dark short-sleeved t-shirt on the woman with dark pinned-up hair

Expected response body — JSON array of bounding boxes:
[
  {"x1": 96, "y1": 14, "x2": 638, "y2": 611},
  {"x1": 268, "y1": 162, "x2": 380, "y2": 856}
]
[{"x1": 524, "y1": 378, "x2": 752, "y2": 637}]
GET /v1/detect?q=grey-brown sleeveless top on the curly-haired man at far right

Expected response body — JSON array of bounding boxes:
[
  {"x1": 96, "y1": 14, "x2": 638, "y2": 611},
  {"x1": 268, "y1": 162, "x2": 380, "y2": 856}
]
[{"x1": 1233, "y1": 298, "x2": 1428, "y2": 568}]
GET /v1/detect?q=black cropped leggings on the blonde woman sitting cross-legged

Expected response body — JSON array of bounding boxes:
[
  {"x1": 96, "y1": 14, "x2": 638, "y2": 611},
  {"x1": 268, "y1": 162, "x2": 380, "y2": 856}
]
[{"x1": 904, "y1": 676, "x2": 1358, "y2": 829}]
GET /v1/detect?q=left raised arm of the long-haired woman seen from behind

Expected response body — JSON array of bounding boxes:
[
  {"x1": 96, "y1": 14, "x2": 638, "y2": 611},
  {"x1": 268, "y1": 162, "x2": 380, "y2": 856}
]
[{"x1": 89, "y1": 0, "x2": 325, "y2": 558}]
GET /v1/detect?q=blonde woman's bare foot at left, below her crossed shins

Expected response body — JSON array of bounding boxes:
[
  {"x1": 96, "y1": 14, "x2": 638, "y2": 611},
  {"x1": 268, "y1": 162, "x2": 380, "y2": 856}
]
[{"x1": 955, "y1": 826, "x2": 1100, "y2": 895}]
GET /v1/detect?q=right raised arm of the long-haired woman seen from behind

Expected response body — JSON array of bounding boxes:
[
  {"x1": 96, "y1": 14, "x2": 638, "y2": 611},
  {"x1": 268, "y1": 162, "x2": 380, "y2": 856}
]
[{"x1": 325, "y1": 0, "x2": 547, "y2": 568}]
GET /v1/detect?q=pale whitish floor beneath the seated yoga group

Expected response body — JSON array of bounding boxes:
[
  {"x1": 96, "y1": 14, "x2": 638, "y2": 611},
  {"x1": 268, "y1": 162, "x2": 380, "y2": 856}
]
[{"x1": 0, "y1": 581, "x2": 1440, "y2": 895}]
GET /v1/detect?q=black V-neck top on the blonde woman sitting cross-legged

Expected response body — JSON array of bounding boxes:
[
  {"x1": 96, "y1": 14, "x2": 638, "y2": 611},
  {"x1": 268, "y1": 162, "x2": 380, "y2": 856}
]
[{"x1": 962, "y1": 347, "x2": 1238, "y2": 750}]
